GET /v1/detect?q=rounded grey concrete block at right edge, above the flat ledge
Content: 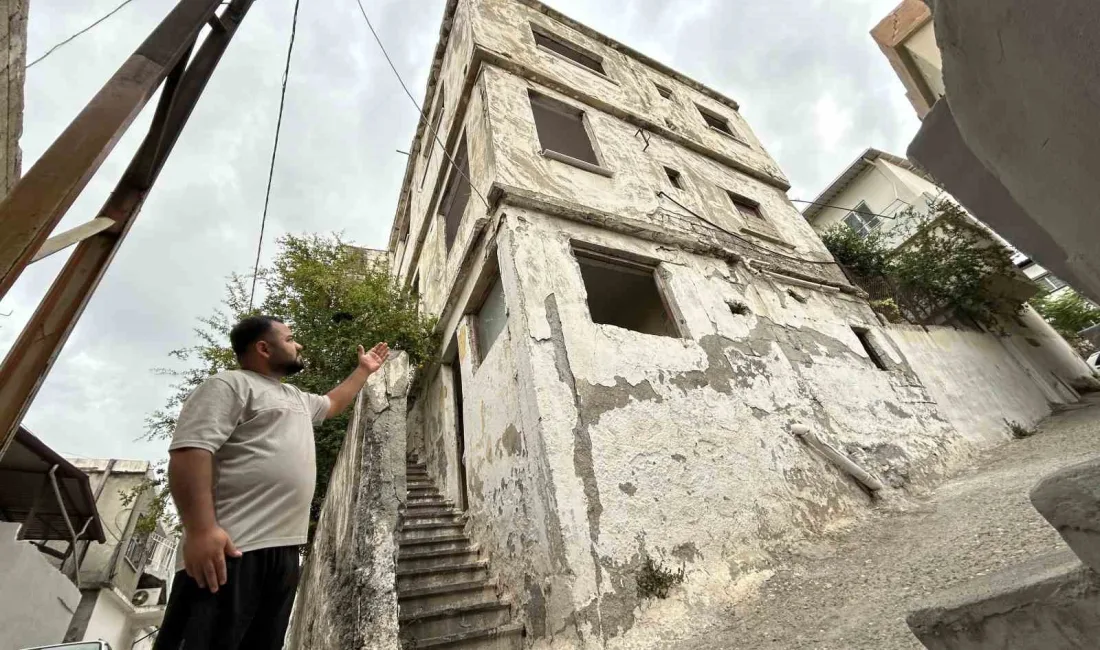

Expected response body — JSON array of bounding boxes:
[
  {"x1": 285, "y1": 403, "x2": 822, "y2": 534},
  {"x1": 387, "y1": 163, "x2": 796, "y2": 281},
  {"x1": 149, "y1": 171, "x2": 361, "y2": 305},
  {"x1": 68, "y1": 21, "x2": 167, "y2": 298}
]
[{"x1": 1031, "y1": 459, "x2": 1100, "y2": 571}]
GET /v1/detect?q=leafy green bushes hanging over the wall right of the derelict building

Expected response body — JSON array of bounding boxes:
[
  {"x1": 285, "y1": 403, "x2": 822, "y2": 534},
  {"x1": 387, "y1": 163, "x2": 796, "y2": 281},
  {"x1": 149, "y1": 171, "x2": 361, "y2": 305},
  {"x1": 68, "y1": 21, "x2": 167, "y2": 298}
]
[{"x1": 822, "y1": 199, "x2": 1022, "y2": 326}]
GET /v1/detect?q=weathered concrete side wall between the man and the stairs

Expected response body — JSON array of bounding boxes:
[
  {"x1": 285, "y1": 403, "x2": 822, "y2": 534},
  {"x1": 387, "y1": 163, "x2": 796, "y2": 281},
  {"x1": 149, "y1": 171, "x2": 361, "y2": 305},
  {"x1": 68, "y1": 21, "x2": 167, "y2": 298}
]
[{"x1": 286, "y1": 353, "x2": 409, "y2": 650}]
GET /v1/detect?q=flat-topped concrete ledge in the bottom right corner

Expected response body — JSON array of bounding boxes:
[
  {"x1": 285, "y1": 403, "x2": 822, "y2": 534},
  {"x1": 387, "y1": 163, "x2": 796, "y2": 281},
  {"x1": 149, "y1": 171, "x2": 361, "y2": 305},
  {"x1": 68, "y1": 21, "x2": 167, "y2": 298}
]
[{"x1": 906, "y1": 551, "x2": 1100, "y2": 650}]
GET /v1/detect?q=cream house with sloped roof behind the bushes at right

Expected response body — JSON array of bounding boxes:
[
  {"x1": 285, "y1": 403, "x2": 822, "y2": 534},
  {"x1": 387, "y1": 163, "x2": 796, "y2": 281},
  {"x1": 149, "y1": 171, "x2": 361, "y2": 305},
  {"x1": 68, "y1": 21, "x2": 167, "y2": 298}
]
[{"x1": 802, "y1": 148, "x2": 1067, "y2": 301}]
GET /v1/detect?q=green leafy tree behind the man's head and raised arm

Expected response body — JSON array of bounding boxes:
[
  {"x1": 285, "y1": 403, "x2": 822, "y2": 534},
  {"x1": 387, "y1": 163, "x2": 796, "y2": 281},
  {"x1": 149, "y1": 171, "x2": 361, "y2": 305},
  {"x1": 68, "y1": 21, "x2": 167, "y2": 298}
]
[{"x1": 141, "y1": 234, "x2": 437, "y2": 535}]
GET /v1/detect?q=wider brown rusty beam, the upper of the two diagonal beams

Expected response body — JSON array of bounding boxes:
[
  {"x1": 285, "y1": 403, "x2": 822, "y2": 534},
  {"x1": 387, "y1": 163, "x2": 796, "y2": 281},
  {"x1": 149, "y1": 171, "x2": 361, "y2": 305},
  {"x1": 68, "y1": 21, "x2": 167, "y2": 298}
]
[{"x1": 0, "y1": 0, "x2": 220, "y2": 298}]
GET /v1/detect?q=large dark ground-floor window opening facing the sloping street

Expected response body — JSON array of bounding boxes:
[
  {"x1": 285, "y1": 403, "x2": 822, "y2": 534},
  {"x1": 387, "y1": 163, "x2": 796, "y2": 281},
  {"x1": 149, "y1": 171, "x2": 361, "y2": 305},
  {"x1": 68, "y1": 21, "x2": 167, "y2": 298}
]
[{"x1": 573, "y1": 247, "x2": 680, "y2": 338}]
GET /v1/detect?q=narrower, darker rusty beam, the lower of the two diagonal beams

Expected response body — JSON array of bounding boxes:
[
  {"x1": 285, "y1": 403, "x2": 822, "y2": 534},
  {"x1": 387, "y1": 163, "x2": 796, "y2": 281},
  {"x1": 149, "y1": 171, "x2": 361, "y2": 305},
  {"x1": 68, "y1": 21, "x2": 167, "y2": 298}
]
[{"x1": 0, "y1": 0, "x2": 254, "y2": 455}]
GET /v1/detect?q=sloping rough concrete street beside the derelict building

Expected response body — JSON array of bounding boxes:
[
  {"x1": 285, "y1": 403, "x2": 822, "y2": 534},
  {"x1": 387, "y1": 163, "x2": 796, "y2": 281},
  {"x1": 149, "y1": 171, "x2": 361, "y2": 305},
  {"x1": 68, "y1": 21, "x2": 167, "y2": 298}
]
[{"x1": 675, "y1": 397, "x2": 1100, "y2": 650}]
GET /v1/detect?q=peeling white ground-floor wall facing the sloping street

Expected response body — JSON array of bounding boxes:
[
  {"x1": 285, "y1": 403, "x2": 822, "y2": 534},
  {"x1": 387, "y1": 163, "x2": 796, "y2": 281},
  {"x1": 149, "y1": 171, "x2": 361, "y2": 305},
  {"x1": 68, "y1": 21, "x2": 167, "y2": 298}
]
[{"x1": 481, "y1": 210, "x2": 969, "y2": 647}]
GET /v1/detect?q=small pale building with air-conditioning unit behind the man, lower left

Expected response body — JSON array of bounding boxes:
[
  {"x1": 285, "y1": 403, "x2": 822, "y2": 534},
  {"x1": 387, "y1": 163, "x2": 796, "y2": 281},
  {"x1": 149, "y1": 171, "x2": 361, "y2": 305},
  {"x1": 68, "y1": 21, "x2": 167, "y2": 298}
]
[{"x1": 58, "y1": 458, "x2": 176, "y2": 650}]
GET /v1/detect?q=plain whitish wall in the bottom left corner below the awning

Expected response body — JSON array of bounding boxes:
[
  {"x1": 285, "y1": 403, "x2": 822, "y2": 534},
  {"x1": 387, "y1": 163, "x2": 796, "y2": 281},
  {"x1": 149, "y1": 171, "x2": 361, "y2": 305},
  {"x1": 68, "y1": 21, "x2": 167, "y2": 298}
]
[{"x1": 0, "y1": 522, "x2": 80, "y2": 650}]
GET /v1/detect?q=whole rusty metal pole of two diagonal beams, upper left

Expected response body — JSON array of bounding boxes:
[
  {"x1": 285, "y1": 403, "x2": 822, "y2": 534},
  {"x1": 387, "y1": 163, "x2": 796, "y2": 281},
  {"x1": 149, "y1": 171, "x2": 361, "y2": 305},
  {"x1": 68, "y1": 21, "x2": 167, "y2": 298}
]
[{"x1": 0, "y1": 0, "x2": 254, "y2": 456}]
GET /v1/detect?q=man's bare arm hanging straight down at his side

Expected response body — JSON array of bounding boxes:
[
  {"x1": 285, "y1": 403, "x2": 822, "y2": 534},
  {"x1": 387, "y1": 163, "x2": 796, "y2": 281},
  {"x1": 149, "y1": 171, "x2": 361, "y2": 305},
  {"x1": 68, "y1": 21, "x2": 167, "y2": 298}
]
[{"x1": 168, "y1": 448, "x2": 241, "y2": 593}]
